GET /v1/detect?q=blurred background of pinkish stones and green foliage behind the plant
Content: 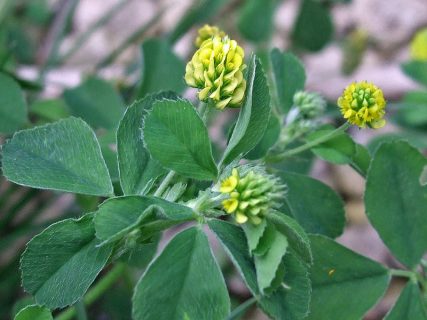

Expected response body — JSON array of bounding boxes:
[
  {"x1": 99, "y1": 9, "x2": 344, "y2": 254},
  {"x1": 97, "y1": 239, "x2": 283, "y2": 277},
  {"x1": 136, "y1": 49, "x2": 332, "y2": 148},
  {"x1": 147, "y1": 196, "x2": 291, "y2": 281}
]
[{"x1": 0, "y1": 0, "x2": 427, "y2": 320}]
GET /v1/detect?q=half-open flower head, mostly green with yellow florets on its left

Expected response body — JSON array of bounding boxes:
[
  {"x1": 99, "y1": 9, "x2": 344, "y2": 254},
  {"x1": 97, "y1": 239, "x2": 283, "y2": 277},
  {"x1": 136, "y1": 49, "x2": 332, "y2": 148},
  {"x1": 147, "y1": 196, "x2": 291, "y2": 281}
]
[{"x1": 219, "y1": 167, "x2": 285, "y2": 225}]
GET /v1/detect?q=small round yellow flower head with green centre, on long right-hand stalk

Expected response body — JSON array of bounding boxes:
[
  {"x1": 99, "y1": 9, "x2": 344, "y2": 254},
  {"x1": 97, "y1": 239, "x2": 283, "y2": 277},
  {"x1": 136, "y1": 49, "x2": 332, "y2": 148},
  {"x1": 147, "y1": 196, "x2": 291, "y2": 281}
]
[{"x1": 337, "y1": 81, "x2": 386, "y2": 129}]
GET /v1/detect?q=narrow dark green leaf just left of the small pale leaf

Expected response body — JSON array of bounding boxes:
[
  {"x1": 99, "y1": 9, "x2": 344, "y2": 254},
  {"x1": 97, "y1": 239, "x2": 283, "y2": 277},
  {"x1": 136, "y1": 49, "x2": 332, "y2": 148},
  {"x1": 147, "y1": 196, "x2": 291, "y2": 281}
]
[{"x1": 208, "y1": 220, "x2": 259, "y2": 296}]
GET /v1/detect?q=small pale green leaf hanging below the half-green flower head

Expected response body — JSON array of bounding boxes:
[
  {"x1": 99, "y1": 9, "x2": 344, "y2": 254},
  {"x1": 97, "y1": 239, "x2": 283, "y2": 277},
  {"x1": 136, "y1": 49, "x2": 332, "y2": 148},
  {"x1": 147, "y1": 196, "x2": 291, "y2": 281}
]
[{"x1": 254, "y1": 231, "x2": 288, "y2": 293}]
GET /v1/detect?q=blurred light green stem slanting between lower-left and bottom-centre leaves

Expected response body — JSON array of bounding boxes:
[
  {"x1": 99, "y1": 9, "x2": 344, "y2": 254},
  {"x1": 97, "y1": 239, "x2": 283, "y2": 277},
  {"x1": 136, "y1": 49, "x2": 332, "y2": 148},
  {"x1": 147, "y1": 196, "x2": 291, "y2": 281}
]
[{"x1": 55, "y1": 263, "x2": 126, "y2": 320}]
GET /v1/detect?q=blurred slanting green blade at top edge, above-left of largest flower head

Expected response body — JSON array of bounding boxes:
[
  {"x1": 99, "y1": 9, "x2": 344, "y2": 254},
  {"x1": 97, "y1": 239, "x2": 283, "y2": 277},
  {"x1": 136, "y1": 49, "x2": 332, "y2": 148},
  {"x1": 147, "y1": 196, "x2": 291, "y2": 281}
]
[{"x1": 168, "y1": 0, "x2": 228, "y2": 43}]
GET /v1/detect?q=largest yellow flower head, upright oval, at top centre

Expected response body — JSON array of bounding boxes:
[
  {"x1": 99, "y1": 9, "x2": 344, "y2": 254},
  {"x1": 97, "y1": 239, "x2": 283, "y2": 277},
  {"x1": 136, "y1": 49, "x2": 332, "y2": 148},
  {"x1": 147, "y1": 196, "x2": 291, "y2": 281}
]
[{"x1": 185, "y1": 36, "x2": 246, "y2": 110}]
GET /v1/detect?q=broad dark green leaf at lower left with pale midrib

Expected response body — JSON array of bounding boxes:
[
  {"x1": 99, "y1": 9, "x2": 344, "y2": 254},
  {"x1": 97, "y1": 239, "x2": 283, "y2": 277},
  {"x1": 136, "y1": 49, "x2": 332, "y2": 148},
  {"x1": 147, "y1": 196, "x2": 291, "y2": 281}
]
[{"x1": 21, "y1": 214, "x2": 112, "y2": 309}]
